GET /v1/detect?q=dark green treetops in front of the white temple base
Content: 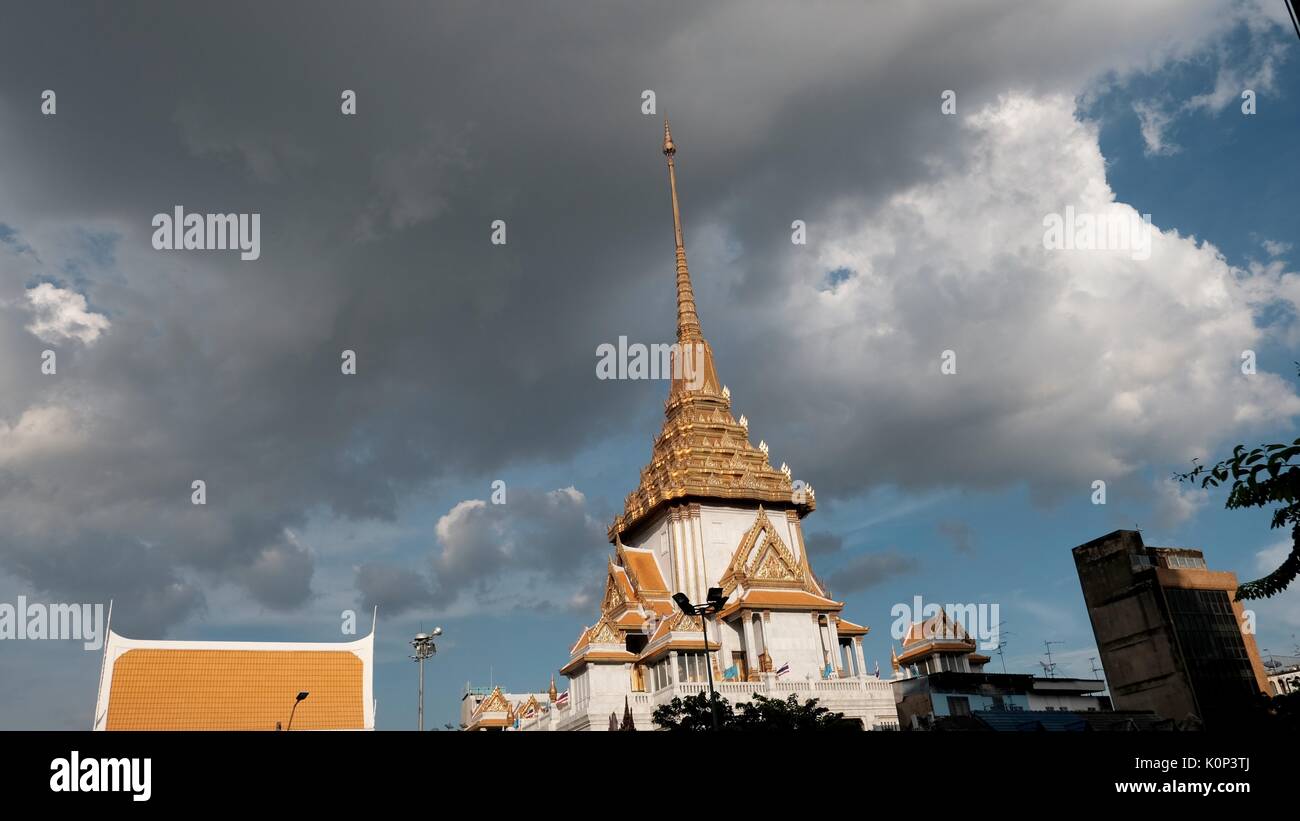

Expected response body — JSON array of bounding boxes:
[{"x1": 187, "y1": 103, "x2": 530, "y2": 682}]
[{"x1": 653, "y1": 692, "x2": 862, "y2": 731}]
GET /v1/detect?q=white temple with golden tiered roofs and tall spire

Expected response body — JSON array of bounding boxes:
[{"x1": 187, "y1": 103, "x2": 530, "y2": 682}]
[{"x1": 512, "y1": 120, "x2": 897, "y2": 730}]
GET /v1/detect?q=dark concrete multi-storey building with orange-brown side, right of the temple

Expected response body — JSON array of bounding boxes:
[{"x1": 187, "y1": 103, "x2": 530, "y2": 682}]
[{"x1": 1074, "y1": 530, "x2": 1270, "y2": 729}]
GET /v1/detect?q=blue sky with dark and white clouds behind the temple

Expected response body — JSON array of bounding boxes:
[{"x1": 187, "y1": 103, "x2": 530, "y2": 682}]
[{"x1": 0, "y1": 0, "x2": 1300, "y2": 729}]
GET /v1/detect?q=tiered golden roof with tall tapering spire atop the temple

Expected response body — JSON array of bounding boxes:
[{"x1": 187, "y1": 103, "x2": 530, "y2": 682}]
[{"x1": 610, "y1": 118, "x2": 815, "y2": 540}]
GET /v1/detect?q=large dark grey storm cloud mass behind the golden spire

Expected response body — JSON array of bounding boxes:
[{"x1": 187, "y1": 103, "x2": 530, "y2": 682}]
[{"x1": 0, "y1": 0, "x2": 1279, "y2": 631}]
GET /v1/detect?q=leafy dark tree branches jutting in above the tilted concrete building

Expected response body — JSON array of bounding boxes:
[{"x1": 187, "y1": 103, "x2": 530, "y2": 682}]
[{"x1": 1175, "y1": 439, "x2": 1300, "y2": 600}]
